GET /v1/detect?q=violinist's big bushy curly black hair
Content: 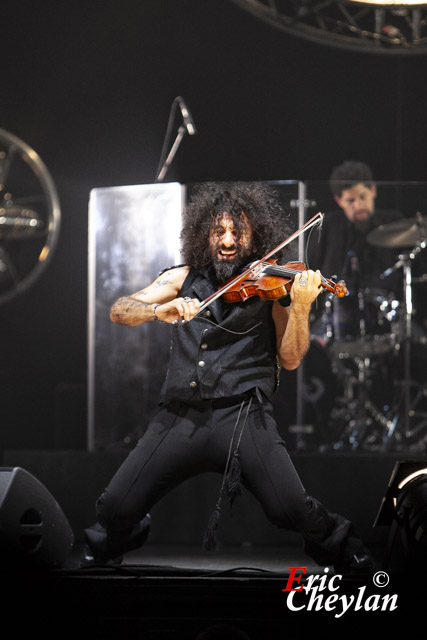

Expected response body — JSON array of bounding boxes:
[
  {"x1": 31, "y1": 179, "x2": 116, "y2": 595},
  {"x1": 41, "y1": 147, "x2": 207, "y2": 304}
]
[{"x1": 181, "y1": 182, "x2": 293, "y2": 269}]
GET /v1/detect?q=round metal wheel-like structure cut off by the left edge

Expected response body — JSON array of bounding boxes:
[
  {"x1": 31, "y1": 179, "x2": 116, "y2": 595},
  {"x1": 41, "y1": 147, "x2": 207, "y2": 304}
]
[{"x1": 0, "y1": 129, "x2": 61, "y2": 304}]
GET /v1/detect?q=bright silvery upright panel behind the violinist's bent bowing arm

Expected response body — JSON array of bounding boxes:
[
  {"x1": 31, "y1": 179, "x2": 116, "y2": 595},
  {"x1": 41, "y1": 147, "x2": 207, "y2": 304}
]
[{"x1": 88, "y1": 183, "x2": 185, "y2": 450}]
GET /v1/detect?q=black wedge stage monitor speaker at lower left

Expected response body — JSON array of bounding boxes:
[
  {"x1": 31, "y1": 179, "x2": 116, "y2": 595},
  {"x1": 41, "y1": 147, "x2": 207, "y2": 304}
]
[{"x1": 0, "y1": 467, "x2": 74, "y2": 567}]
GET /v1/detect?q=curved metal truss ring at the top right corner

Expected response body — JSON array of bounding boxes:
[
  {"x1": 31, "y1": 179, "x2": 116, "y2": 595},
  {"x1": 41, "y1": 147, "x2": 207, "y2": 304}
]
[{"x1": 231, "y1": 0, "x2": 427, "y2": 55}]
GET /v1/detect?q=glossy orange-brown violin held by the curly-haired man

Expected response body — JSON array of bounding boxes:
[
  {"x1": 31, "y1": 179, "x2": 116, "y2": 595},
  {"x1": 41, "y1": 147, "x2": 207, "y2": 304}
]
[{"x1": 222, "y1": 260, "x2": 348, "y2": 302}]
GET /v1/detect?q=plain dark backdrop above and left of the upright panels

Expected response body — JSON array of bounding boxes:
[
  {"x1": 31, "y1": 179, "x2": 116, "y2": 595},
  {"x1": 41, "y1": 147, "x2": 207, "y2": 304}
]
[{"x1": 0, "y1": 0, "x2": 427, "y2": 452}]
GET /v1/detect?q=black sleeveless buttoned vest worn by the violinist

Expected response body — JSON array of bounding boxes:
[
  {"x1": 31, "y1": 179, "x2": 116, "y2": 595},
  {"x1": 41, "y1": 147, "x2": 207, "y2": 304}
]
[{"x1": 161, "y1": 268, "x2": 277, "y2": 403}]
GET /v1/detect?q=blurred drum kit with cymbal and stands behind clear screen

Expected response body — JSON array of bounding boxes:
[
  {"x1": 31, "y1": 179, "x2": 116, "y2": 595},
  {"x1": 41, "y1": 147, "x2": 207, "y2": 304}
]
[{"x1": 302, "y1": 214, "x2": 427, "y2": 452}]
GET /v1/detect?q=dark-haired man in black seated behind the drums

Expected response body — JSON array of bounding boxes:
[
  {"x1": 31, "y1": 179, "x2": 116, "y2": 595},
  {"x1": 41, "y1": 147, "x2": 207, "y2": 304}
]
[{"x1": 307, "y1": 160, "x2": 403, "y2": 294}]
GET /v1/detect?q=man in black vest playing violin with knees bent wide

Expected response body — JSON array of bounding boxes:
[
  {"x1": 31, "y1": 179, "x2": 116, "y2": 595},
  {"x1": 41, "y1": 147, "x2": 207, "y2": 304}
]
[{"x1": 82, "y1": 183, "x2": 372, "y2": 572}]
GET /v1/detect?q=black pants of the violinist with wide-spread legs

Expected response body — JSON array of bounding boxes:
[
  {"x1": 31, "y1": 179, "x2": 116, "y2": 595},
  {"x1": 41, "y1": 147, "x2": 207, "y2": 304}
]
[{"x1": 89, "y1": 396, "x2": 363, "y2": 564}]
